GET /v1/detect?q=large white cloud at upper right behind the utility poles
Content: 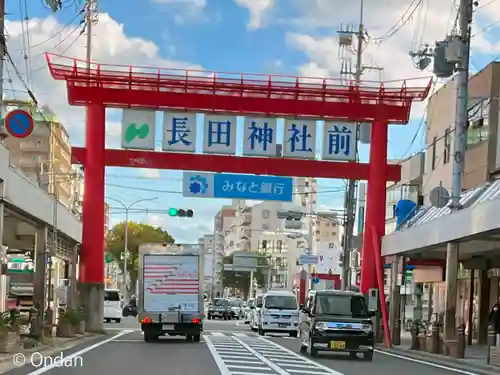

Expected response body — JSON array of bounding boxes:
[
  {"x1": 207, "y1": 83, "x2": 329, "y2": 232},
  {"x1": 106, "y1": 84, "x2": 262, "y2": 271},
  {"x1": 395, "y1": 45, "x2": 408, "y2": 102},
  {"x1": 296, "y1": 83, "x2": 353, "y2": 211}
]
[{"x1": 262, "y1": 0, "x2": 500, "y2": 125}]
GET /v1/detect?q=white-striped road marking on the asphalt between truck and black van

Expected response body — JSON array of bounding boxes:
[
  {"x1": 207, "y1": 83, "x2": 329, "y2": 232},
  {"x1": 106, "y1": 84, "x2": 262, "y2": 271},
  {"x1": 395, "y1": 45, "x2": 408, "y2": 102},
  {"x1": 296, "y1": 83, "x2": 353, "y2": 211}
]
[{"x1": 203, "y1": 332, "x2": 343, "y2": 375}]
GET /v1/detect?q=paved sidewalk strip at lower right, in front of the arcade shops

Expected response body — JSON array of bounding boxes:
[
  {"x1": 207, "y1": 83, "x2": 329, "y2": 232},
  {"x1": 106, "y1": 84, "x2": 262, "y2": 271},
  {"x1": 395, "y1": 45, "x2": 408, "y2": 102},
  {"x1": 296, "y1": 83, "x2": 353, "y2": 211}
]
[{"x1": 377, "y1": 332, "x2": 500, "y2": 375}]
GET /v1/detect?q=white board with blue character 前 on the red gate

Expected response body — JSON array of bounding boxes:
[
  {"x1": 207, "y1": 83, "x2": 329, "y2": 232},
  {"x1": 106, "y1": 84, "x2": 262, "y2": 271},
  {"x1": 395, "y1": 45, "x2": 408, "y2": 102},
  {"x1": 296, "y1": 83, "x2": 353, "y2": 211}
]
[{"x1": 322, "y1": 121, "x2": 358, "y2": 161}]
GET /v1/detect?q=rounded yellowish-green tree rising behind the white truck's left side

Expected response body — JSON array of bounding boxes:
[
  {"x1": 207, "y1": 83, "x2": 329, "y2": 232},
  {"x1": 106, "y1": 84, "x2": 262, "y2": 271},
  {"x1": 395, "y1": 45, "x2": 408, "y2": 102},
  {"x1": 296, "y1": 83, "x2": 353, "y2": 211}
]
[{"x1": 106, "y1": 221, "x2": 175, "y2": 292}]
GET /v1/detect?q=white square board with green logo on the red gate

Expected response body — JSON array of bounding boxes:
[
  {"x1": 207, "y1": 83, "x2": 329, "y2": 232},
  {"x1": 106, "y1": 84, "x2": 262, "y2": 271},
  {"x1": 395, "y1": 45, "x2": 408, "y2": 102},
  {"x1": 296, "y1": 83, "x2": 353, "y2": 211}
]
[{"x1": 122, "y1": 109, "x2": 156, "y2": 150}]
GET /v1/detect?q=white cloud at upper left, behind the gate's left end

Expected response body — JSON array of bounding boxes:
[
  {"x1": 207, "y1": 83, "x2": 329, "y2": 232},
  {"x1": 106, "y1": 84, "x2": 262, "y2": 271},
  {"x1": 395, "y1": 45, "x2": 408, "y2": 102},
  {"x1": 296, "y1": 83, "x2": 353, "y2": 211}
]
[{"x1": 5, "y1": 13, "x2": 202, "y2": 147}]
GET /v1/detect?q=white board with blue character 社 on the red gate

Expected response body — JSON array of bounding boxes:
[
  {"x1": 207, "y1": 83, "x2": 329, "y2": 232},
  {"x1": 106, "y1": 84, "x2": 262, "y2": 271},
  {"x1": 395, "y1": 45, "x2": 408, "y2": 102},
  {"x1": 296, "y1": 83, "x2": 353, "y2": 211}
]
[{"x1": 283, "y1": 119, "x2": 316, "y2": 159}]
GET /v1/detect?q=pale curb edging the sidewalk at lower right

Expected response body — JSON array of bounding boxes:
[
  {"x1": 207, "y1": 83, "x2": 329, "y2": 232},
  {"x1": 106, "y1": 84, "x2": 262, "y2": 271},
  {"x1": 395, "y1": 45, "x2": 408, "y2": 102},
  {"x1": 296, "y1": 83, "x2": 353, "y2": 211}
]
[{"x1": 375, "y1": 347, "x2": 499, "y2": 375}]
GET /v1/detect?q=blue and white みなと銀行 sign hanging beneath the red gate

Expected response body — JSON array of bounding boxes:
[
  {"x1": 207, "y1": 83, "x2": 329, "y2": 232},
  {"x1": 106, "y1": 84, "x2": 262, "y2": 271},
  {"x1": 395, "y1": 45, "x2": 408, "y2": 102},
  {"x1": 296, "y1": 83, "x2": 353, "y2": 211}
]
[{"x1": 182, "y1": 172, "x2": 293, "y2": 202}]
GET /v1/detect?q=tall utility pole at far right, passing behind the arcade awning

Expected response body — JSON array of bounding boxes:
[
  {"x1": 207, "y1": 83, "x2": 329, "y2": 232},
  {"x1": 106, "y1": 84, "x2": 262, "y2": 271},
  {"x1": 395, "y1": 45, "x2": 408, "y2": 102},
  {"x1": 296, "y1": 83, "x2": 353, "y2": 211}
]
[{"x1": 444, "y1": 0, "x2": 474, "y2": 342}]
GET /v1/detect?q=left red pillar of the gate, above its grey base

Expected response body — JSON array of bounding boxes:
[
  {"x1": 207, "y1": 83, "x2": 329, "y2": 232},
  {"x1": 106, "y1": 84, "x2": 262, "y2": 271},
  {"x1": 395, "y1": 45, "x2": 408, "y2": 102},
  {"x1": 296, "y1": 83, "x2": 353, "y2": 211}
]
[{"x1": 79, "y1": 104, "x2": 106, "y2": 284}]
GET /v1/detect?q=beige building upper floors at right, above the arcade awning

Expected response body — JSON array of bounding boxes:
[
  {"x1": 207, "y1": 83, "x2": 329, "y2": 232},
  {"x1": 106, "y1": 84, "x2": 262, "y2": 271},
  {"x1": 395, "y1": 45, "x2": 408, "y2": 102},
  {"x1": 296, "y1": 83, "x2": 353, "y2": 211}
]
[{"x1": 422, "y1": 62, "x2": 500, "y2": 204}]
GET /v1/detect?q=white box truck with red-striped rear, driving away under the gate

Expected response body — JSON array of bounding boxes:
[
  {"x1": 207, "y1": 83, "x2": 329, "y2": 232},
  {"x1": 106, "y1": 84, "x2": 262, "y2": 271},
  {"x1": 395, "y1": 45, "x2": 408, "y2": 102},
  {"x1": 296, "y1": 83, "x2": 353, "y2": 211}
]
[{"x1": 137, "y1": 243, "x2": 205, "y2": 342}]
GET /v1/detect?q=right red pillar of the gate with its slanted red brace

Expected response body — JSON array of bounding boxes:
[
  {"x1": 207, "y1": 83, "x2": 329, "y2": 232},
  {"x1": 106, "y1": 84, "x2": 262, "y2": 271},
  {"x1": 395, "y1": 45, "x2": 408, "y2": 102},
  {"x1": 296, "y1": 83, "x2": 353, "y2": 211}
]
[{"x1": 361, "y1": 122, "x2": 388, "y2": 293}]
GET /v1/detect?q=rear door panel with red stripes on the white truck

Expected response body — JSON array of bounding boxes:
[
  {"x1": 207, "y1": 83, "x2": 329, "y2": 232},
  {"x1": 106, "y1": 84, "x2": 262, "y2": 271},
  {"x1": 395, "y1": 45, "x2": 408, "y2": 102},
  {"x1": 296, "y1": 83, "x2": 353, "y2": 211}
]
[{"x1": 143, "y1": 254, "x2": 199, "y2": 312}]
